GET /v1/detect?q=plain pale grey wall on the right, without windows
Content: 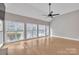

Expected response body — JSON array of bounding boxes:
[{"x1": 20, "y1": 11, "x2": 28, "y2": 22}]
[{"x1": 50, "y1": 10, "x2": 79, "y2": 39}]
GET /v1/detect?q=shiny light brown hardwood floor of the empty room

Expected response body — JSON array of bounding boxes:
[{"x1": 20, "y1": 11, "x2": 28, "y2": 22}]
[{"x1": 4, "y1": 37, "x2": 79, "y2": 55}]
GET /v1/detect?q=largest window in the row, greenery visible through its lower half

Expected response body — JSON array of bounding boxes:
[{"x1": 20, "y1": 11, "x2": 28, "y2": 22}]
[{"x1": 6, "y1": 21, "x2": 24, "y2": 42}]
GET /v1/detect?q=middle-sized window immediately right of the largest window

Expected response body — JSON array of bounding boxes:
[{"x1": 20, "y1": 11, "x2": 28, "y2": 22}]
[{"x1": 26, "y1": 23, "x2": 37, "y2": 39}]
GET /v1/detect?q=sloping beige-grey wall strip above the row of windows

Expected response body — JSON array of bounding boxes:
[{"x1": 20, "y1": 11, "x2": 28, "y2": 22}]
[{"x1": 5, "y1": 12, "x2": 49, "y2": 25}]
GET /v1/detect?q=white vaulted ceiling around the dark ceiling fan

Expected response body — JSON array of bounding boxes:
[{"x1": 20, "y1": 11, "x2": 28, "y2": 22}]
[{"x1": 5, "y1": 3, "x2": 79, "y2": 21}]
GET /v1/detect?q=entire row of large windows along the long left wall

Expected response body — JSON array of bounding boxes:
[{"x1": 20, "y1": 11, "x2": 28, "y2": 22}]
[{"x1": 4, "y1": 21, "x2": 49, "y2": 42}]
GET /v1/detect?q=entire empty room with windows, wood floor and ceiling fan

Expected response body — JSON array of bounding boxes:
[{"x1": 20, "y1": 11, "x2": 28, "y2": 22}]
[{"x1": 0, "y1": 3, "x2": 79, "y2": 55}]
